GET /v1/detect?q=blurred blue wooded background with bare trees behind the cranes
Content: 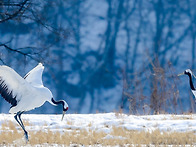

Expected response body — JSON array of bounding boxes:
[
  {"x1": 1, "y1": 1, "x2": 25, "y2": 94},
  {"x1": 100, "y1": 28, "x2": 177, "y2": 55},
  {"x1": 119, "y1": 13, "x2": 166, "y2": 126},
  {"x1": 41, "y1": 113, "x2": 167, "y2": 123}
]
[{"x1": 0, "y1": 0, "x2": 196, "y2": 114}]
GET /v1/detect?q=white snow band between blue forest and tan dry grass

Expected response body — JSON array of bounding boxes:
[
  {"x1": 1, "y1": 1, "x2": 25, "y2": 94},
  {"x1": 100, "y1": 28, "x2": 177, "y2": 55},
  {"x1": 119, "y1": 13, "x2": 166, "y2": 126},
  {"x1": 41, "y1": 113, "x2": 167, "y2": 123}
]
[{"x1": 0, "y1": 113, "x2": 196, "y2": 146}]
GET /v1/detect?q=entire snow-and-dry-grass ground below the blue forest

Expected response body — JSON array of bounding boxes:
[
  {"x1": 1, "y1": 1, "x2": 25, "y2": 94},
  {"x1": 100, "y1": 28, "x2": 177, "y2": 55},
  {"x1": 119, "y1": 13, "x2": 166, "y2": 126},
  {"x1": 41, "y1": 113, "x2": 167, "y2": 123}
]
[{"x1": 0, "y1": 113, "x2": 196, "y2": 147}]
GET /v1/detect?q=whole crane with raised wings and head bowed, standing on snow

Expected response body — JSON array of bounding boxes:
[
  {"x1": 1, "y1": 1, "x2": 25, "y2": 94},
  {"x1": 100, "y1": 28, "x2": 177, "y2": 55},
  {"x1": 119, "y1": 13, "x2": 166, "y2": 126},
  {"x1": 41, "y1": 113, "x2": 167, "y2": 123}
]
[{"x1": 0, "y1": 63, "x2": 68, "y2": 141}]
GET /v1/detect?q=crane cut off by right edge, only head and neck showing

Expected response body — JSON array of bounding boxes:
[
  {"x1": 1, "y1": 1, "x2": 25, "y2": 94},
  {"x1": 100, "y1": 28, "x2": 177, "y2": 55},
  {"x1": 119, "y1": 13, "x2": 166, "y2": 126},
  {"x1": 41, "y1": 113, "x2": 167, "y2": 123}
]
[{"x1": 178, "y1": 69, "x2": 196, "y2": 99}]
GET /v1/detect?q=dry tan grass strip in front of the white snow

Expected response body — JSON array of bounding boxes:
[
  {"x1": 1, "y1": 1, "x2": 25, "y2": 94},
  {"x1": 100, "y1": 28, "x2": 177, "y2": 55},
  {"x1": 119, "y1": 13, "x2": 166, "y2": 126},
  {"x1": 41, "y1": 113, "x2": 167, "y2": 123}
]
[{"x1": 0, "y1": 121, "x2": 196, "y2": 146}]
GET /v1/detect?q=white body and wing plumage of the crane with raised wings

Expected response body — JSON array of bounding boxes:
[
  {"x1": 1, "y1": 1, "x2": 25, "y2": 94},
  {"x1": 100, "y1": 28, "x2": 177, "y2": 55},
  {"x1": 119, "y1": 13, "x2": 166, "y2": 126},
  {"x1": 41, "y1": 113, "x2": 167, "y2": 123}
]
[{"x1": 0, "y1": 64, "x2": 53, "y2": 113}]
